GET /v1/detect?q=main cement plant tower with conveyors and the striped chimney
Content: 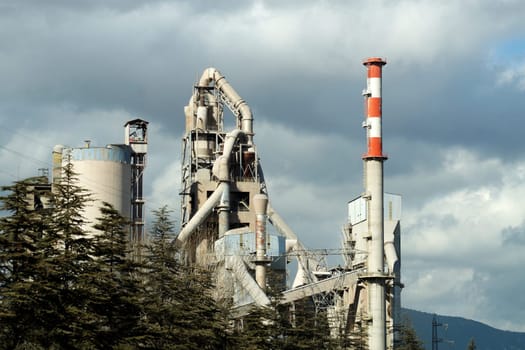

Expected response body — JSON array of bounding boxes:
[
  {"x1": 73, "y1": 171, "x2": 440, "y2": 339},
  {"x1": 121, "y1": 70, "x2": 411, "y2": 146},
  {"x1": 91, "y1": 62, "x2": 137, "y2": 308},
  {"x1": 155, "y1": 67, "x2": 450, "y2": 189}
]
[{"x1": 175, "y1": 58, "x2": 401, "y2": 349}]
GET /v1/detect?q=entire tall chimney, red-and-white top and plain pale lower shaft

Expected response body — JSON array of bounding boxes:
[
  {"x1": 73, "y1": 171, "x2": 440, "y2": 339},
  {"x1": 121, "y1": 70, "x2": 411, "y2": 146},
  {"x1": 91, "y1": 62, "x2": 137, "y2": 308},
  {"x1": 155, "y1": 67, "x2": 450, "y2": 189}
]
[{"x1": 363, "y1": 57, "x2": 386, "y2": 350}]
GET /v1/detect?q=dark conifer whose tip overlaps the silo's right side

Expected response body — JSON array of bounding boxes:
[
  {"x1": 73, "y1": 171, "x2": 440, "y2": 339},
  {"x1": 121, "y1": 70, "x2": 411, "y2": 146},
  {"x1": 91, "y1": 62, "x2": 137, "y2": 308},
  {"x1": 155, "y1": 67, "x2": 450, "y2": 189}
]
[{"x1": 89, "y1": 203, "x2": 144, "y2": 348}]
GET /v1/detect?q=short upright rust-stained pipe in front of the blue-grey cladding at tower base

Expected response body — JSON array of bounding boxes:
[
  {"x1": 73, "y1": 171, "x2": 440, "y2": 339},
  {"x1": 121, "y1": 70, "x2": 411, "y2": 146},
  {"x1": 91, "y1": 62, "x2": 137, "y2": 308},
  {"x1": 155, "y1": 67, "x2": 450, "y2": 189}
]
[{"x1": 253, "y1": 194, "x2": 268, "y2": 290}]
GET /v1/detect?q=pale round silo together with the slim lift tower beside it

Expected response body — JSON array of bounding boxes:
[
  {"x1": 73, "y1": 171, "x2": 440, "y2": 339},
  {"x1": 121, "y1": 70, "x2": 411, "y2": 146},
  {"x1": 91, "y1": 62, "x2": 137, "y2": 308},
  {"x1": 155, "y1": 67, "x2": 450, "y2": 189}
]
[{"x1": 52, "y1": 119, "x2": 148, "y2": 246}]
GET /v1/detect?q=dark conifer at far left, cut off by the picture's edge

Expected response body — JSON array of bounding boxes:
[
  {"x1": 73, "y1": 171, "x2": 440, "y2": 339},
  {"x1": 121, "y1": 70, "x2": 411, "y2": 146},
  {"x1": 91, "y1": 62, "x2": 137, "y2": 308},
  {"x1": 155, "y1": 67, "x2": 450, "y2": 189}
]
[{"x1": 0, "y1": 178, "x2": 55, "y2": 349}]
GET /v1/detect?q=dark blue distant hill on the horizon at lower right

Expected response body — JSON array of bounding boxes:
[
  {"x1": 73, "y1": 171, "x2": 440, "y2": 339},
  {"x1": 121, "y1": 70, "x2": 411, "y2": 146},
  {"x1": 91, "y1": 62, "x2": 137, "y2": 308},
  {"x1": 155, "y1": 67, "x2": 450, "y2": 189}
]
[{"x1": 402, "y1": 309, "x2": 525, "y2": 350}]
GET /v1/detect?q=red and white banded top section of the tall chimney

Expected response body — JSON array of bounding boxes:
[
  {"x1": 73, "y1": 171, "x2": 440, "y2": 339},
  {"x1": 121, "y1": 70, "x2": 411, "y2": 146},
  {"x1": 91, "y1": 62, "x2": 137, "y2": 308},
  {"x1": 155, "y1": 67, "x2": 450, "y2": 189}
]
[{"x1": 363, "y1": 57, "x2": 386, "y2": 159}]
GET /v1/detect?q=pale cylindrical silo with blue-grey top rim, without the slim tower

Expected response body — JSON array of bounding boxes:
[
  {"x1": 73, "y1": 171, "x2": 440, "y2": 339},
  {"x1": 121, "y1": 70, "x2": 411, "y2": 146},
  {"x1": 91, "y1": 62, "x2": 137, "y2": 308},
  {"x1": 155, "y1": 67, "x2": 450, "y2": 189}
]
[{"x1": 56, "y1": 143, "x2": 132, "y2": 234}]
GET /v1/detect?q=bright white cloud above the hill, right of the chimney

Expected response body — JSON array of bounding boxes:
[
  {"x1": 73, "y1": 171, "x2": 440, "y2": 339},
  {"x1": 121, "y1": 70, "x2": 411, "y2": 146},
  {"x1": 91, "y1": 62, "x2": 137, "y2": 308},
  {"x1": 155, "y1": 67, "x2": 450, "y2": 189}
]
[{"x1": 402, "y1": 148, "x2": 525, "y2": 330}]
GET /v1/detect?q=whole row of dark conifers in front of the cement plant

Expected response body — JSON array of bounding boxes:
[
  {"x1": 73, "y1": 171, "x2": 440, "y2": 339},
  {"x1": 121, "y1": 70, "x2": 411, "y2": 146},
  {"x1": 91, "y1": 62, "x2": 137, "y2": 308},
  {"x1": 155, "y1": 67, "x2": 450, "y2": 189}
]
[{"x1": 0, "y1": 176, "x2": 346, "y2": 350}]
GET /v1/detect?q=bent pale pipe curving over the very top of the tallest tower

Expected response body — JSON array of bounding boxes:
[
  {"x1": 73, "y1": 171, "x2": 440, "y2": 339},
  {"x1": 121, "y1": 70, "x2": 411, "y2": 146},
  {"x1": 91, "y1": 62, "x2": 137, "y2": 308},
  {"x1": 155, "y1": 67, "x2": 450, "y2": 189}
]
[{"x1": 198, "y1": 67, "x2": 253, "y2": 144}]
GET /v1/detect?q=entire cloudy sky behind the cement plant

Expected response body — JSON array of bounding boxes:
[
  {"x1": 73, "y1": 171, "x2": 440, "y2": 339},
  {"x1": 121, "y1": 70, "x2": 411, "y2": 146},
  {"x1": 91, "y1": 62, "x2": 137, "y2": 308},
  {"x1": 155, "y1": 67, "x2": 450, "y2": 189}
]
[{"x1": 0, "y1": 0, "x2": 525, "y2": 331}]
